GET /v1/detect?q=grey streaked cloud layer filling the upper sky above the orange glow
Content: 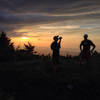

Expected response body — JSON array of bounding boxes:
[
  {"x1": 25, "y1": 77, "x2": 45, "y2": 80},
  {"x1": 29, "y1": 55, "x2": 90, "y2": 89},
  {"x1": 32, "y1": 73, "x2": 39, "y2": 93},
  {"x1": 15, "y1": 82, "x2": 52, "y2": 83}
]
[{"x1": 0, "y1": 0, "x2": 100, "y2": 36}]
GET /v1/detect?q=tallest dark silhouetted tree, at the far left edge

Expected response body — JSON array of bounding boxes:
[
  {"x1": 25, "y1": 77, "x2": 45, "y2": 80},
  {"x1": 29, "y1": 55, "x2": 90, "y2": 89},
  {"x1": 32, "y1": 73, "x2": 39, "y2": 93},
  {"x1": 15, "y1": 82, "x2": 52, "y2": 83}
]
[{"x1": 0, "y1": 32, "x2": 14, "y2": 60}]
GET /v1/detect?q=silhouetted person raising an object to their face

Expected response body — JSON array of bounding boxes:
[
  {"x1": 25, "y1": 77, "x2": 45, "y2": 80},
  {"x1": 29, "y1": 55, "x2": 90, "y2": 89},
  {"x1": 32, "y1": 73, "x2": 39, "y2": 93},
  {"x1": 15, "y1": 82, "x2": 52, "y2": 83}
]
[{"x1": 51, "y1": 36, "x2": 62, "y2": 64}]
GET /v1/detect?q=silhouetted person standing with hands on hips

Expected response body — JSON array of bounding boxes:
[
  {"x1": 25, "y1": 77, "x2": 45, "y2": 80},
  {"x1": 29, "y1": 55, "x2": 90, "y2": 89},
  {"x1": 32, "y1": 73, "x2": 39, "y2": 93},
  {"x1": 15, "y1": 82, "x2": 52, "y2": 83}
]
[{"x1": 80, "y1": 34, "x2": 96, "y2": 64}]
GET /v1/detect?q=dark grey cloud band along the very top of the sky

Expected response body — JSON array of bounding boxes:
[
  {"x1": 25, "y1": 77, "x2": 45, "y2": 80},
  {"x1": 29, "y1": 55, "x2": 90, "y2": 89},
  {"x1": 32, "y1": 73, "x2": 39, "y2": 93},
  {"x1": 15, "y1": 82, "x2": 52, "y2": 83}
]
[{"x1": 0, "y1": 0, "x2": 100, "y2": 14}]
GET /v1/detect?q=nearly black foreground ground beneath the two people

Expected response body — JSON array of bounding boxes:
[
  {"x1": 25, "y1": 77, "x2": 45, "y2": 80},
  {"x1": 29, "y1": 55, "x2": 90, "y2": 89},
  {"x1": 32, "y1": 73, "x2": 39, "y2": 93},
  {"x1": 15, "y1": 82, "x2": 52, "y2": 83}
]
[{"x1": 0, "y1": 57, "x2": 100, "y2": 100}]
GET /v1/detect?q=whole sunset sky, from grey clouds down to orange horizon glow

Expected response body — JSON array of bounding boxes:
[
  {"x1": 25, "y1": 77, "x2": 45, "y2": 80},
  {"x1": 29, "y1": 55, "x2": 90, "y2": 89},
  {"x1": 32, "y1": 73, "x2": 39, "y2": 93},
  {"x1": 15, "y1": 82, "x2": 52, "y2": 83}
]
[{"x1": 0, "y1": 0, "x2": 100, "y2": 55}]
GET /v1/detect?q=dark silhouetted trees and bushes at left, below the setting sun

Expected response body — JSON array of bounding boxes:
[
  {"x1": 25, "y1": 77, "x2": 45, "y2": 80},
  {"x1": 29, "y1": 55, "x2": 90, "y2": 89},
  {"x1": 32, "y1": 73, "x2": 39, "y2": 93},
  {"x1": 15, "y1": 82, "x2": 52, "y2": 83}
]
[{"x1": 0, "y1": 32, "x2": 36, "y2": 62}]
